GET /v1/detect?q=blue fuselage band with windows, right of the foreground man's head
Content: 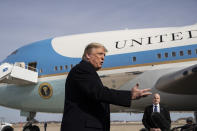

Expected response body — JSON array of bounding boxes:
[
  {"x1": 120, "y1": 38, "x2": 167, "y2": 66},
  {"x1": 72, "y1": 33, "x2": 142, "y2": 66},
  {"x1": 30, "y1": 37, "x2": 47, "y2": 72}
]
[{"x1": 103, "y1": 44, "x2": 197, "y2": 67}]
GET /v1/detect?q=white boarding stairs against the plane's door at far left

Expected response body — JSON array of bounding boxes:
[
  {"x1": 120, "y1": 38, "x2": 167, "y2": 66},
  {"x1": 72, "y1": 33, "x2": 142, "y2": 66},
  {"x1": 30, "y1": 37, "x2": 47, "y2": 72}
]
[{"x1": 0, "y1": 62, "x2": 38, "y2": 85}]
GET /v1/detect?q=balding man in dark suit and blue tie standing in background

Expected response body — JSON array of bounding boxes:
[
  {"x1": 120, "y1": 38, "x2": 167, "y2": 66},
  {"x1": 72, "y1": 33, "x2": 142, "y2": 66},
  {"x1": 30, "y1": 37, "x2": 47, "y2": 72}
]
[{"x1": 142, "y1": 93, "x2": 171, "y2": 131}]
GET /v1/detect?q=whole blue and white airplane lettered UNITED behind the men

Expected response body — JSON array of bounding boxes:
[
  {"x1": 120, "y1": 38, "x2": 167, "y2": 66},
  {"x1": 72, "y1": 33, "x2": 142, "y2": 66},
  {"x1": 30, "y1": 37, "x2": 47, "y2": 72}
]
[{"x1": 0, "y1": 24, "x2": 197, "y2": 131}]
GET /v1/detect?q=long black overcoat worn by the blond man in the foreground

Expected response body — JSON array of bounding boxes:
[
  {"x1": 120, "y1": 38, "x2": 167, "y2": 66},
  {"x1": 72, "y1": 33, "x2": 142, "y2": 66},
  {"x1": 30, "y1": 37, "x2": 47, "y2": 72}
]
[{"x1": 61, "y1": 61, "x2": 131, "y2": 131}]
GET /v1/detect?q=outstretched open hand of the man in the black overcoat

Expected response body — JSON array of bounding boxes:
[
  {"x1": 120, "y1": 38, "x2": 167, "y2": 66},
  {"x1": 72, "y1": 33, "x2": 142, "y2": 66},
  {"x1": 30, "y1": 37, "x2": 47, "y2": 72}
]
[{"x1": 131, "y1": 84, "x2": 152, "y2": 100}]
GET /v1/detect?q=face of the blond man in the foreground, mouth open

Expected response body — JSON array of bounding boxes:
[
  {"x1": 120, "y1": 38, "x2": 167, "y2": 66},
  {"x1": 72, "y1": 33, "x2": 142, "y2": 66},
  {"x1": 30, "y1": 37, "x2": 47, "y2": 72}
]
[{"x1": 86, "y1": 47, "x2": 105, "y2": 70}]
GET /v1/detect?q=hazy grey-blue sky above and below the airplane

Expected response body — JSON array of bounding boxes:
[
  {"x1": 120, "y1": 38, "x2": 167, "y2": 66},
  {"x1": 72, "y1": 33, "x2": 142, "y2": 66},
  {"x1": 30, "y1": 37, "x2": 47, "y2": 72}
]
[{"x1": 0, "y1": 0, "x2": 197, "y2": 120}]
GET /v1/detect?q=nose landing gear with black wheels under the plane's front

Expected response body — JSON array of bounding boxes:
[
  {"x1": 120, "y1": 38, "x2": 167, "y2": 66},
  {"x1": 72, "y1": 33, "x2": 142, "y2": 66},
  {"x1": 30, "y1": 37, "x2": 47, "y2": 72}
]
[{"x1": 21, "y1": 112, "x2": 40, "y2": 131}]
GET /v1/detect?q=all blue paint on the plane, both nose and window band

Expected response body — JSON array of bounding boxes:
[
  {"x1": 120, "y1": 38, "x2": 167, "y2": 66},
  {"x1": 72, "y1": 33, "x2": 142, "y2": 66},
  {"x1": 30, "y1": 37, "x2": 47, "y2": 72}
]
[{"x1": 3, "y1": 39, "x2": 197, "y2": 76}]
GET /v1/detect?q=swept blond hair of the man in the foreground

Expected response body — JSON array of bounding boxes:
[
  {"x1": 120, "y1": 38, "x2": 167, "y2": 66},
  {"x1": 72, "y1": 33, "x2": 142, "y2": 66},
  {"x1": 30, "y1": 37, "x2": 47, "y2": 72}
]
[{"x1": 82, "y1": 42, "x2": 107, "y2": 60}]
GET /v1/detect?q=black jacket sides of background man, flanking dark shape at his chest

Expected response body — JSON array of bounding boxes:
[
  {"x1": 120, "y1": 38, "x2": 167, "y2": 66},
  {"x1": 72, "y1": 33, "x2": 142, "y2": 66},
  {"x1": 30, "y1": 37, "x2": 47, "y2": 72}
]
[{"x1": 142, "y1": 105, "x2": 171, "y2": 130}]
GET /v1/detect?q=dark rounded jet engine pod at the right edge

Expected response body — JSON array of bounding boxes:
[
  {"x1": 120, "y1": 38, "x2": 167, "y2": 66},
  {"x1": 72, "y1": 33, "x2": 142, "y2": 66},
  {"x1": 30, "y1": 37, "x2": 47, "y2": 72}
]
[{"x1": 155, "y1": 64, "x2": 197, "y2": 95}]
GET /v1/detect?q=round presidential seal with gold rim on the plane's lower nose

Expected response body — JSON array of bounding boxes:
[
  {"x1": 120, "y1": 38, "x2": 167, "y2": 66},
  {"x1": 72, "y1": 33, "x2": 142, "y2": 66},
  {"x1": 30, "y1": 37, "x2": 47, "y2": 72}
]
[{"x1": 38, "y1": 83, "x2": 53, "y2": 99}]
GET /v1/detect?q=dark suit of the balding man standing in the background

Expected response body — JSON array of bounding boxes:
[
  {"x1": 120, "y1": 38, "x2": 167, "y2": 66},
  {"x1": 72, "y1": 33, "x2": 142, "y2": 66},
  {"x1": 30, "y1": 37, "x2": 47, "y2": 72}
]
[{"x1": 142, "y1": 105, "x2": 171, "y2": 131}]
